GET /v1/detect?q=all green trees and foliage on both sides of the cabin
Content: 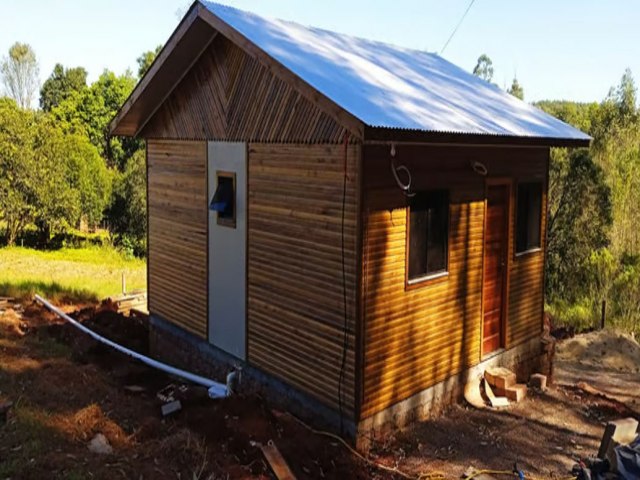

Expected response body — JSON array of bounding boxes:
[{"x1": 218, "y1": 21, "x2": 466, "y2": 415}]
[{"x1": 0, "y1": 46, "x2": 640, "y2": 333}]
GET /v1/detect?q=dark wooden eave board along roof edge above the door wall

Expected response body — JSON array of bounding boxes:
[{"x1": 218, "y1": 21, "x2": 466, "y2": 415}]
[{"x1": 364, "y1": 126, "x2": 591, "y2": 148}]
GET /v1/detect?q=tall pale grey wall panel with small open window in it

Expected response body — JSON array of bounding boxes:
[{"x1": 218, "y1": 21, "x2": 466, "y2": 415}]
[{"x1": 208, "y1": 142, "x2": 247, "y2": 360}]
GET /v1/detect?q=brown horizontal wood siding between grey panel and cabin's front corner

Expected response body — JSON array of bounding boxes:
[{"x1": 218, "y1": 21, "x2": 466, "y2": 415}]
[{"x1": 248, "y1": 143, "x2": 360, "y2": 415}]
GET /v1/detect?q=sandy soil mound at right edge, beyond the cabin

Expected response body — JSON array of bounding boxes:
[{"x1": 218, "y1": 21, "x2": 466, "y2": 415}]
[{"x1": 556, "y1": 330, "x2": 640, "y2": 372}]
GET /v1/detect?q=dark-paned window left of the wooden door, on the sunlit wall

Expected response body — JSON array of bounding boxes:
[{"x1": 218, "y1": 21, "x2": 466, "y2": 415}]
[{"x1": 408, "y1": 190, "x2": 449, "y2": 281}]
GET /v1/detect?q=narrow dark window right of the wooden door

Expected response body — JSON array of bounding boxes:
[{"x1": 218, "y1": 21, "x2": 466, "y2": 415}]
[{"x1": 516, "y1": 183, "x2": 542, "y2": 253}]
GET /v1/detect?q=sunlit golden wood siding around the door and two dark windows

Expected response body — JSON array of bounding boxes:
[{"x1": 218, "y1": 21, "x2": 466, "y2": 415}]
[{"x1": 361, "y1": 146, "x2": 548, "y2": 418}]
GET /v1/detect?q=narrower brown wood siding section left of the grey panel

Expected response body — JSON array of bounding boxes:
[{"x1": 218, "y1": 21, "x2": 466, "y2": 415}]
[{"x1": 147, "y1": 140, "x2": 207, "y2": 338}]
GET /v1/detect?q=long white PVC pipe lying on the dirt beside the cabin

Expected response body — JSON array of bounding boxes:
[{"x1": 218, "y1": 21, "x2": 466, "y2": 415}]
[{"x1": 35, "y1": 295, "x2": 229, "y2": 398}]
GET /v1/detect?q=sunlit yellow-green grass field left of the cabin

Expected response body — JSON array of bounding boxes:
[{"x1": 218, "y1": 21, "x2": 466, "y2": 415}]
[{"x1": 0, "y1": 247, "x2": 147, "y2": 302}]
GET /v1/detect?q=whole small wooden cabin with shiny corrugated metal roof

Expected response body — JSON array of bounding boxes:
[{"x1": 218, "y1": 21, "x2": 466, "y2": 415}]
[{"x1": 111, "y1": 2, "x2": 589, "y2": 440}]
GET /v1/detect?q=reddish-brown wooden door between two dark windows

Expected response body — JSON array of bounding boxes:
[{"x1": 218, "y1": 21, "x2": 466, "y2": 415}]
[{"x1": 482, "y1": 185, "x2": 510, "y2": 355}]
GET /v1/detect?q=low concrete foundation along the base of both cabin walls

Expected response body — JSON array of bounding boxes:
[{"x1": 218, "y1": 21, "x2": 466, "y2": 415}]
[{"x1": 150, "y1": 315, "x2": 544, "y2": 450}]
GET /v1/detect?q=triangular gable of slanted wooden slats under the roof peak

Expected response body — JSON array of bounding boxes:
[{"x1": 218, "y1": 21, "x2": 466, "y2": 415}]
[{"x1": 141, "y1": 35, "x2": 345, "y2": 143}]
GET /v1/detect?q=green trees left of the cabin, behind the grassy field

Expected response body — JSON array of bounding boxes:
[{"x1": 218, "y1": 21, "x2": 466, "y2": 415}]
[{"x1": 0, "y1": 43, "x2": 159, "y2": 254}]
